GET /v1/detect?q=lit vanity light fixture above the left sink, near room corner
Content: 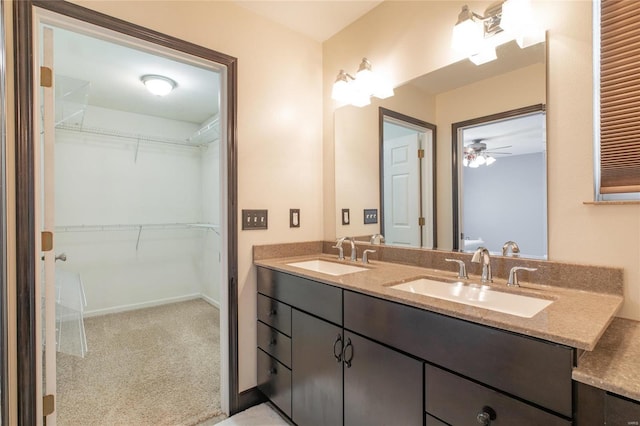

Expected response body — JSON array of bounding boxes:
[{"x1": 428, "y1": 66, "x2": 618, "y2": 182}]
[{"x1": 331, "y1": 58, "x2": 393, "y2": 107}]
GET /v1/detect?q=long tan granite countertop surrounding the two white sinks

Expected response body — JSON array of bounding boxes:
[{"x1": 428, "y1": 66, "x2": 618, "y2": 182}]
[{"x1": 254, "y1": 254, "x2": 624, "y2": 351}]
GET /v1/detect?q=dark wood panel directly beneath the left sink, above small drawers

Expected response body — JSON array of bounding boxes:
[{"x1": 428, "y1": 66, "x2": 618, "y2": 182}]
[{"x1": 257, "y1": 267, "x2": 342, "y2": 324}]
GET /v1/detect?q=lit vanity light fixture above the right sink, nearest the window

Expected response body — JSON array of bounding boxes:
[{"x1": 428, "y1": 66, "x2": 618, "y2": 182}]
[{"x1": 451, "y1": 0, "x2": 544, "y2": 65}]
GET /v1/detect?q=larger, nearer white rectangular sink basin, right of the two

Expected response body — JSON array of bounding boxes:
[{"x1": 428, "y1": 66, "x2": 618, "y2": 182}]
[{"x1": 390, "y1": 278, "x2": 553, "y2": 318}]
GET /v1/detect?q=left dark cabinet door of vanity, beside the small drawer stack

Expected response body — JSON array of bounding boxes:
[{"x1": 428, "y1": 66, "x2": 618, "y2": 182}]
[{"x1": 291, "y1": 309, "x2": 343, "y2": 426}]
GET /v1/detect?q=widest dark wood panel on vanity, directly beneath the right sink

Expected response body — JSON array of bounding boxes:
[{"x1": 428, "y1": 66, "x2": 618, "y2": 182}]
[{"x1": 344, "y1": 291, "x2": 573, "y2": 417}]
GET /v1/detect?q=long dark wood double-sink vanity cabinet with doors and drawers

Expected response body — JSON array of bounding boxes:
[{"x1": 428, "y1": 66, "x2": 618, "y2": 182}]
[{"x1": 258, "y1": 267, "x2": 596, "y2": 426}]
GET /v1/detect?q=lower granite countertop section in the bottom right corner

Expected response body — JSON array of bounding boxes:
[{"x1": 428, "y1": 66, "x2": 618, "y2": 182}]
[{"x1": 573, "y1": 318, "x2": 640, "y2": 401}]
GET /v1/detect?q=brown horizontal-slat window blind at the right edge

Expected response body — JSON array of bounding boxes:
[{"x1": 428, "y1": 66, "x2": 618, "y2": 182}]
[{"x1": 600, "y1": 0, "x2": 640, "y2": 194}]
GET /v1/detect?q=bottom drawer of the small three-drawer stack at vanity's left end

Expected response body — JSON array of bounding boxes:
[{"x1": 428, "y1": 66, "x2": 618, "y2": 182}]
[{"x1": 257, "y1": 349, "x2": 291, "y2": 417}]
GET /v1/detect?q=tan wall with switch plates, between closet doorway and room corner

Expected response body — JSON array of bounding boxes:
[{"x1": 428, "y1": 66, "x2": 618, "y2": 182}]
[{"x1": 60, "y1": 0, "x2": 322, "y2": 390}]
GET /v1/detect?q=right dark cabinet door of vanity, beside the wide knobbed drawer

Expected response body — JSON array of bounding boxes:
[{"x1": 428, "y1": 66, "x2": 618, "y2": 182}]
[{"x1": 344, "y1": 330, "x2": 424, "y2": 426}]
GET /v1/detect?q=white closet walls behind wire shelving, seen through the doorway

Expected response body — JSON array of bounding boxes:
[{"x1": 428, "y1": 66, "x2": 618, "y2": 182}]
[{"x1": 55, "y1": 107, "x2": 224, "y2": 315}]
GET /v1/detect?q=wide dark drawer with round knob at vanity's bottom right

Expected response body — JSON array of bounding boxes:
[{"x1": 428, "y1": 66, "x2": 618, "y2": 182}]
[{"x1": 425, "y1": 365, "x2": 571, "y2": 426}]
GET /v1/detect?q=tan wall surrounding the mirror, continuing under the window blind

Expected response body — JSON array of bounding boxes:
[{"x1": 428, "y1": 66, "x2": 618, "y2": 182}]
[{"x1": 323, "y1": 0, "x2": 640, "y2": 320}]
